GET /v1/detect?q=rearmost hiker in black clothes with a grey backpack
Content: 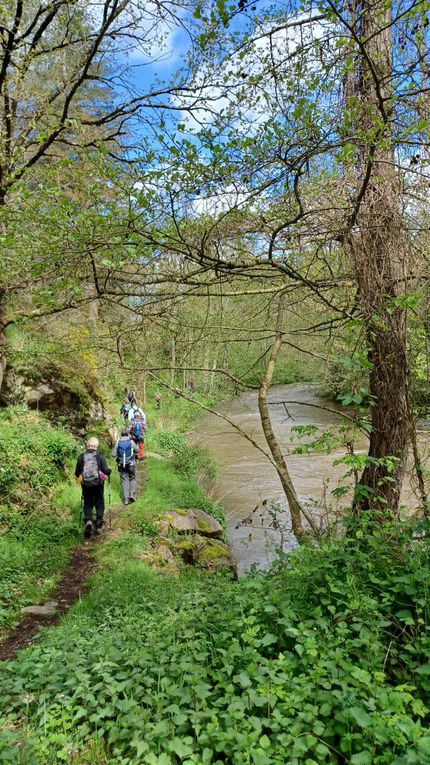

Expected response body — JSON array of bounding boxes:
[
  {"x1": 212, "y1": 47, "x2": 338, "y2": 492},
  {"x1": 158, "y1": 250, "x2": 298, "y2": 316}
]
[{"x1": 75, "y1": 436, "x2": 112, "y2": 539}]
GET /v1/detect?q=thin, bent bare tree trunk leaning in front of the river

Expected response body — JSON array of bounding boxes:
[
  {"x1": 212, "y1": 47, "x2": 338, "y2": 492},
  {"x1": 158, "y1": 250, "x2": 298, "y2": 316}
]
[{"x1": 258, "y1": 294, "x2": 308, "y2": 542}]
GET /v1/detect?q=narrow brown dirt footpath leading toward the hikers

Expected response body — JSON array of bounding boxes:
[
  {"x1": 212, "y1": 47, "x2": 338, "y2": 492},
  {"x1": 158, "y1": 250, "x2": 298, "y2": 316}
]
[{"x1": 0, "y1": 468, "x2": 145, "y2": 661}]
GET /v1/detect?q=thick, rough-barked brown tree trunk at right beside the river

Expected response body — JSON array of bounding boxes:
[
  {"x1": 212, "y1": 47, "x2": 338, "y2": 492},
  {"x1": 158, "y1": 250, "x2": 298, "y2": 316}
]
[{"x1": 347, "y1": 0, "x2": 410, "y2": 517}]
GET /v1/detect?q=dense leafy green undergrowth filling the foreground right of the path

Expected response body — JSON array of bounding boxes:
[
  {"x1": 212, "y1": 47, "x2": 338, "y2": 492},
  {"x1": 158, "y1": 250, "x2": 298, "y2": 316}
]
[{"x1": 0, "y1": 516, "x2": 430, "y2": 765}]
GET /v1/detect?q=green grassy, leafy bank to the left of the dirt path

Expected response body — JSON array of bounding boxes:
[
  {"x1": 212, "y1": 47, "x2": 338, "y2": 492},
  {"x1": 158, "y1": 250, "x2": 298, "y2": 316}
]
[{"x1": 0, "y1": 407, "x2": 117, "y2": 636}]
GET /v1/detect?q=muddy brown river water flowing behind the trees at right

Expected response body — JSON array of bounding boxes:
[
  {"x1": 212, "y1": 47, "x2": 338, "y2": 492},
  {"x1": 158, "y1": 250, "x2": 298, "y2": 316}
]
[{"x1": 192, "y1": 384, "x2": 426, "y2": 574}]
